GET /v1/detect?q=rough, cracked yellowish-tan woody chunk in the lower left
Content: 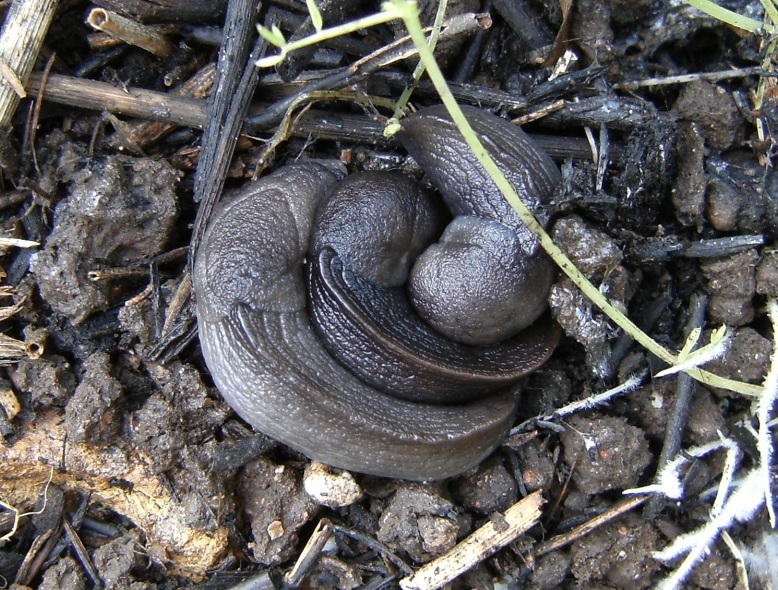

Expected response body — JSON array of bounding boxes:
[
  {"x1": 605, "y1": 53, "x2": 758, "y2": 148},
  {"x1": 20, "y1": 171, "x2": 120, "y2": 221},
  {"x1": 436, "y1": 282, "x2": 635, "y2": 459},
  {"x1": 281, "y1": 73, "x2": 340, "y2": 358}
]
[{"x1": 0, "y1": 411, "x2": 227, "y2": 580}]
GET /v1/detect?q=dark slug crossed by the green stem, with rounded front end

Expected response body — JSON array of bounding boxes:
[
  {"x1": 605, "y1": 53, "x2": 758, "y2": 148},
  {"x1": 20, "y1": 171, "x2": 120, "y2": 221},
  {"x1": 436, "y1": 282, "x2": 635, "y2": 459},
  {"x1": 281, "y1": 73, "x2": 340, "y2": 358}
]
[{"x1": 397, "y1": 105, "x2": 561, "y2": 345}]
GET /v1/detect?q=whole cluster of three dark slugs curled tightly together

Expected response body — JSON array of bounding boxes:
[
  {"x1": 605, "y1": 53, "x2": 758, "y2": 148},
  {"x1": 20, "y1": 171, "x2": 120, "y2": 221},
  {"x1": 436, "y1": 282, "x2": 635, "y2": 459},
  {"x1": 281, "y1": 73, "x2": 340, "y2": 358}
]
[{"x1": 193, "y1": 107, "x2": 559, "y2": 480}]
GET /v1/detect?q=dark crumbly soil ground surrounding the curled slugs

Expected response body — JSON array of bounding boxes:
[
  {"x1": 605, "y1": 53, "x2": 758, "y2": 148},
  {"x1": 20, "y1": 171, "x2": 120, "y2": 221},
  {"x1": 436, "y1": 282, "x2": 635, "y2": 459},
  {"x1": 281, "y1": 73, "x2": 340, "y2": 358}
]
[{"x1": 0, "y1": 0, "x2": 778, "y2": 590}]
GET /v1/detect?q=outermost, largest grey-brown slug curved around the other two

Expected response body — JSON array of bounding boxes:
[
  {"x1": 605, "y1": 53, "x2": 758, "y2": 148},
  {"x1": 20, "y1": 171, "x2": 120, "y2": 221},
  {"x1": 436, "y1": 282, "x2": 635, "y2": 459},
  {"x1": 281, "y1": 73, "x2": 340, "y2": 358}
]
[{"x1": 194, "y1": 164, "x2": 516, "y2": 480}]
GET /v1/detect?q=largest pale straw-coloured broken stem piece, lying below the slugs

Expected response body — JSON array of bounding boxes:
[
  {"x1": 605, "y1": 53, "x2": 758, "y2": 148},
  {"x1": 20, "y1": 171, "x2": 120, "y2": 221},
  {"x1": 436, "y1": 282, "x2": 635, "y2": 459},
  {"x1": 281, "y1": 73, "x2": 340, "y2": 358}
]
[{"x1": 400, "y1": 491, "x2": 545, "y2": 590}]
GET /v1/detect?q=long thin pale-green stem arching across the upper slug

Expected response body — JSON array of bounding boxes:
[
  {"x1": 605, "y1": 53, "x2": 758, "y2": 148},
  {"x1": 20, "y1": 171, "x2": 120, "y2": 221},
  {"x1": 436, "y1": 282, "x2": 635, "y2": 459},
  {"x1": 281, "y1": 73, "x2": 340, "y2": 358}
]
[{"x1": 394, "y1": 0, "x2": 762, "y2": 397}]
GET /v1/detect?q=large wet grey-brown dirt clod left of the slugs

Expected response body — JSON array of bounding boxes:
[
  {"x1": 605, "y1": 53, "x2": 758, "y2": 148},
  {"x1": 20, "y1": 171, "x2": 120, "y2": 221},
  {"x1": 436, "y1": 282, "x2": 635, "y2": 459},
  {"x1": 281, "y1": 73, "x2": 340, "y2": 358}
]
[{"x1": 30, "y1": 156, "x2": 178, "y2": 323}]
